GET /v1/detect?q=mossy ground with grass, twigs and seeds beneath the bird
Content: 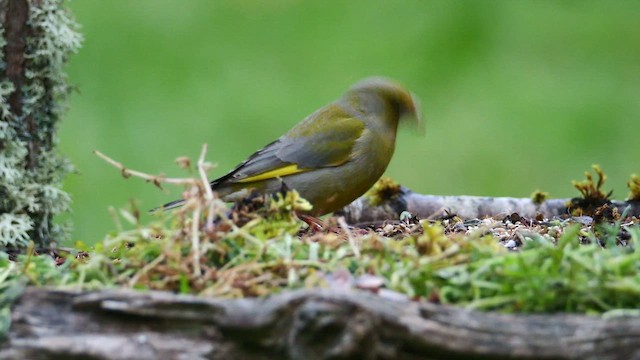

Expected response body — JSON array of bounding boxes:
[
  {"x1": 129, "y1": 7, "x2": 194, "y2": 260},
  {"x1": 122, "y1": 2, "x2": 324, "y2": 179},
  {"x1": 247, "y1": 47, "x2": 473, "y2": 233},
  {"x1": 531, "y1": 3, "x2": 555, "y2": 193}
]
[{"x1": 0, "y1": 166, "x2": 640, "y2": 320}]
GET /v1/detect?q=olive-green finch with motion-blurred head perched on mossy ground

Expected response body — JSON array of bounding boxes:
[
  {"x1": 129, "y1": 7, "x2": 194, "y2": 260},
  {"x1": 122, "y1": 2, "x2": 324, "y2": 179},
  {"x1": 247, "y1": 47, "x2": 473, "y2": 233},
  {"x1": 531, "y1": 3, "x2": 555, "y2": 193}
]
[{"x1": 163, "y1": 77, "x2": 421, "y2": 216}]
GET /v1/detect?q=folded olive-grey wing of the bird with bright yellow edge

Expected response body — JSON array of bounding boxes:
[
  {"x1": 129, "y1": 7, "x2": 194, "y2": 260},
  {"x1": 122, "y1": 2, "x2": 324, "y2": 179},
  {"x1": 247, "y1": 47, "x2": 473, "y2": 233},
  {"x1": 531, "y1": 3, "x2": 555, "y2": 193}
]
[{"x1": 212, "y1": 105, "x2": 365, "y2": 185}]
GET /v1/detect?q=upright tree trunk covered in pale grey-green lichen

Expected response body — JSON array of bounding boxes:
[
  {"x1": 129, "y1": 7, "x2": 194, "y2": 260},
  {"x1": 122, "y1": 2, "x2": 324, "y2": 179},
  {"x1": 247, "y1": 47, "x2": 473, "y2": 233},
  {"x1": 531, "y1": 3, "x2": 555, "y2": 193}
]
[{"x1": 0, "y1": 0, "x2": 81, "y2": 248}]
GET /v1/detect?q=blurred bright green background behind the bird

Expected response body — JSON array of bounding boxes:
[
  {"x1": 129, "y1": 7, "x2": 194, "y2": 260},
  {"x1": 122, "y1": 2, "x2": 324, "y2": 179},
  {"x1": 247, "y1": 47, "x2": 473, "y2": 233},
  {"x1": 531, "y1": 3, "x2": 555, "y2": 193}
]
[{"x1": 60, "y1": 0, "x2": 640, "y2": 242}]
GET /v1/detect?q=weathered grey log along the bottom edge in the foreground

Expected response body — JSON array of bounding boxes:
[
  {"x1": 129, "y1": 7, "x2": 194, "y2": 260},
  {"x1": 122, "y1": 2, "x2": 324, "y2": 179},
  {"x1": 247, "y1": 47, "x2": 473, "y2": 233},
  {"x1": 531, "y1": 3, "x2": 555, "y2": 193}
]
[{"x1": 0, "y1": 288, "x2": 640, "y2": 360}]
